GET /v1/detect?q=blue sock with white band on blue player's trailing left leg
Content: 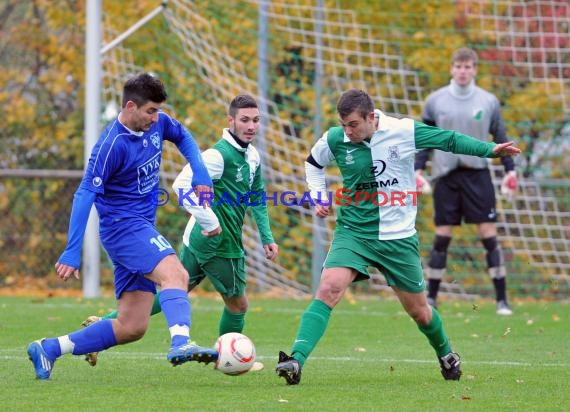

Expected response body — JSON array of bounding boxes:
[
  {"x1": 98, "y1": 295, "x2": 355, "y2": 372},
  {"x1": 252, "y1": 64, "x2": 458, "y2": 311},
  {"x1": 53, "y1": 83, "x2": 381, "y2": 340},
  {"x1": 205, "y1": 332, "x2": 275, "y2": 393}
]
[{"x1": 42, "y1": 319, "x2": 117, "y2": 359}]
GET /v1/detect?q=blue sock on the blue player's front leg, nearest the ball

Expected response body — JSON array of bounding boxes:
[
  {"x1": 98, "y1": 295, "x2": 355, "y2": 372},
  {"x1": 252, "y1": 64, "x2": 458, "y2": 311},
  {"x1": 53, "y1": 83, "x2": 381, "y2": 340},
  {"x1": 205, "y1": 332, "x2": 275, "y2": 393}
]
[{"x1": 158, "y1": 289, "x2": 191, "y2": 347}]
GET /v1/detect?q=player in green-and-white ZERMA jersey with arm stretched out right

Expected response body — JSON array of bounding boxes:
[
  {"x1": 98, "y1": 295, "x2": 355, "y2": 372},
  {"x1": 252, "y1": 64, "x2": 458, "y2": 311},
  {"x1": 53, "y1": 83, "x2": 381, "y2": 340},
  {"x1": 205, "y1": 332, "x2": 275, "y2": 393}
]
[{"x1": 276, "y1": 89, "x2": 520, "y2": 384}]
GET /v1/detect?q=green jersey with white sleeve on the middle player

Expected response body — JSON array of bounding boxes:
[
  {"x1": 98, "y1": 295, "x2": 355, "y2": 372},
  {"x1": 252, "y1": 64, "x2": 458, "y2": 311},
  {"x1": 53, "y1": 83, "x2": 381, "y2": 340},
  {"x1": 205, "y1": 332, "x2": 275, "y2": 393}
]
[{"x1": 173, "y1": 129, "x2": 274, "y2": 258}]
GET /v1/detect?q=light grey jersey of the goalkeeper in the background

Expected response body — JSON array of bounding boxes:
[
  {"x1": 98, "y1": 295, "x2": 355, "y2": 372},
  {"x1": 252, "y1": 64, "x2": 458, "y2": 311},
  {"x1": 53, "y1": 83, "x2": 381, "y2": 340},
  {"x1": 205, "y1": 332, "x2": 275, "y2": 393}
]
[{"x1": 416, "y1": 83, "x2": 513, "y2": 179}]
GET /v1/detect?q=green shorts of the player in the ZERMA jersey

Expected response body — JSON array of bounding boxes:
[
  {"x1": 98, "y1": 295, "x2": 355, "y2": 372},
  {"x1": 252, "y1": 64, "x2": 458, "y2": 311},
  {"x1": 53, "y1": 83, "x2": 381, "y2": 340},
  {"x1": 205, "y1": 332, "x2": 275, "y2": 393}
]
[{"x1": 324, "y1": 231, "x2": 425, "y2": 293}]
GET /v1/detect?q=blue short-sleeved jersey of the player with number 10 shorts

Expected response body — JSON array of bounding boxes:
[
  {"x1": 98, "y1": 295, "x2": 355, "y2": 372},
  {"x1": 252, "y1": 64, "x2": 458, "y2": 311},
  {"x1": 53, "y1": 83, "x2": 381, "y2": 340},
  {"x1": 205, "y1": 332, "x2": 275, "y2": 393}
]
[{"x1": 80, "y1": 112, "x2": 203, "y2": 228}]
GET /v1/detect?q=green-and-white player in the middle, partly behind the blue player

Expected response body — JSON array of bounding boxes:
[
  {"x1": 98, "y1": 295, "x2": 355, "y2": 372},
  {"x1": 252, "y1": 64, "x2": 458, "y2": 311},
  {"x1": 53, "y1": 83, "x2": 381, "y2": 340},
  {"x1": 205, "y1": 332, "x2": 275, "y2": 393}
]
[{"x1": 83, "y1": 95, "x2": 279, "y2": 370}]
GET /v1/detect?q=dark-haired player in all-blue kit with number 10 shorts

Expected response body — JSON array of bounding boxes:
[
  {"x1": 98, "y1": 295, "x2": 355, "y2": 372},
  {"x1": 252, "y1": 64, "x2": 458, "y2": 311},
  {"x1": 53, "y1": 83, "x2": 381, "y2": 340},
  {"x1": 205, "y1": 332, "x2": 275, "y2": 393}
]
[{"x1": 28, "y1": 73, "x2": 218, "y2": 379}]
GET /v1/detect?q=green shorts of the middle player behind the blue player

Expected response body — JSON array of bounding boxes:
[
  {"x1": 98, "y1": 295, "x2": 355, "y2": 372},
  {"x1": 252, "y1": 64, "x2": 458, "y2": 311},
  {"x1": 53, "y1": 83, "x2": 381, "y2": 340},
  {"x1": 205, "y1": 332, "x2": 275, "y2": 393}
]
[{"x1": 180, "y1": 245, "x2": 246, "y2": 298}]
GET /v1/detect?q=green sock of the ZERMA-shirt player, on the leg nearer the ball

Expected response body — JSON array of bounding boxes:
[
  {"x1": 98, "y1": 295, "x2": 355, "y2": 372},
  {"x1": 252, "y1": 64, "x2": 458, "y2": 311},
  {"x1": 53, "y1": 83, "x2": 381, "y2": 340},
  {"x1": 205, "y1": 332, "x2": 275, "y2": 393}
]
[{"x1": 291, "y1": 299, "x2": 332, "y2": 366}]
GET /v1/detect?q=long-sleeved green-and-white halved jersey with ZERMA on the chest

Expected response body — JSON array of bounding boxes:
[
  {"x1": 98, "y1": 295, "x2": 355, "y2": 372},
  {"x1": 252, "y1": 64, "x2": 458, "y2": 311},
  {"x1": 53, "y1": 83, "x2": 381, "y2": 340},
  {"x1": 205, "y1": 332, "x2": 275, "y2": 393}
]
[{"x1": 305, "y1": 109, "x2": 495, "y2": 240}]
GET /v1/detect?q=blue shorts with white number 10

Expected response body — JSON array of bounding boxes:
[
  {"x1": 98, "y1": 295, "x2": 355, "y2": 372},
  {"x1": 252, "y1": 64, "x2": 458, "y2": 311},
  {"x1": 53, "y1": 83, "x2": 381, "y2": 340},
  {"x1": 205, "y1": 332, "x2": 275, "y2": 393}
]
[{"x1": 100, "y1": 218, "x2": 176, "y2": 299}]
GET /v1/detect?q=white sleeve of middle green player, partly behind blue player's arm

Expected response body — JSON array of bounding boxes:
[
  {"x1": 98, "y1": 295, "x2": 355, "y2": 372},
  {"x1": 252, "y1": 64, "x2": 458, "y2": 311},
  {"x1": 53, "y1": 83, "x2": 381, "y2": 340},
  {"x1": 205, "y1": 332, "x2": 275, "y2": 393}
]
[{"x1": 172, "y1": 149, "x2": 224, "y2": 232}]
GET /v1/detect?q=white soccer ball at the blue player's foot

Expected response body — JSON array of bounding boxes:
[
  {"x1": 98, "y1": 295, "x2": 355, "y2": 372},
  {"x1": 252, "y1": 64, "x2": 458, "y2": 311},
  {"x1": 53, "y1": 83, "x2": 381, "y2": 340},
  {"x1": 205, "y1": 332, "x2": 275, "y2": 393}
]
[{"x1": 214, "y1": 332, "x2": 255, "y2": 375}]
